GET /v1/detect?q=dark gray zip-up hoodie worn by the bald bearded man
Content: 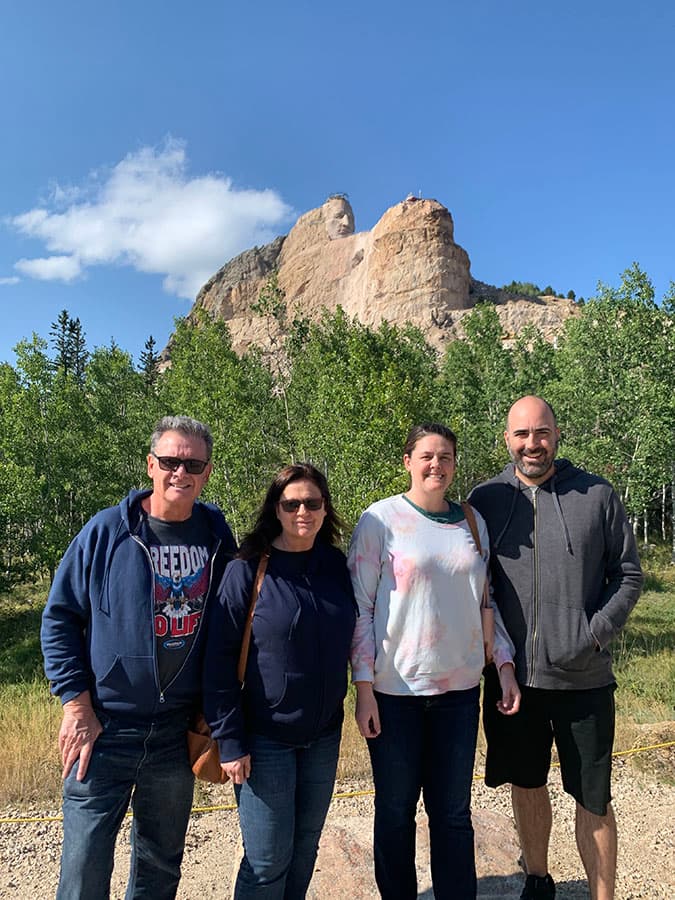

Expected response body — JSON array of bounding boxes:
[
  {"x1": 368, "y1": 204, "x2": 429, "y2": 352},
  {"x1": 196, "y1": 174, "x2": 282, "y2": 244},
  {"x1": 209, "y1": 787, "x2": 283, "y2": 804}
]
[{"x1": 469, "y1": 459, "x2": 642, "y2": 690}]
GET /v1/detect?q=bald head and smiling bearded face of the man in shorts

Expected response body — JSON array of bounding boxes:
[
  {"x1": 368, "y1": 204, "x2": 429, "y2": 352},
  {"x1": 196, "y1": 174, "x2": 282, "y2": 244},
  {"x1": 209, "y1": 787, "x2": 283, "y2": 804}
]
[{"x1": 504, "y1": 396, "x2": 560, "y2": 485}]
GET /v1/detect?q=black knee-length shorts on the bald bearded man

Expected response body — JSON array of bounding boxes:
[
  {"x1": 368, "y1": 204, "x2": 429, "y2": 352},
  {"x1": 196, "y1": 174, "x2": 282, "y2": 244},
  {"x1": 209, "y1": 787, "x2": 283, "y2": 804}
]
[{"x1": 483, "y1": 666, "x2": 616, "y2": 816}]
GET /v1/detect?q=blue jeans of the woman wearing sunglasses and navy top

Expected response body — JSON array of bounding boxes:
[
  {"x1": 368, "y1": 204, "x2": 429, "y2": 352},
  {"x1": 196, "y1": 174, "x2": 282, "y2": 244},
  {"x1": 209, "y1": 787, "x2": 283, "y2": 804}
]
[{"x1": 234, "y1": 728, "x2": 342, "y2": 900}]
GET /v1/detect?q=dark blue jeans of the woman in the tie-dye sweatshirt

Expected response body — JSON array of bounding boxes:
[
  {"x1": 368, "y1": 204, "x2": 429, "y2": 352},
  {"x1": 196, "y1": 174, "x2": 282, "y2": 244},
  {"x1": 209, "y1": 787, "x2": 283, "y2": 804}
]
[{"x1": 368, "y1": 687, "x2": 479, "y2": 900}]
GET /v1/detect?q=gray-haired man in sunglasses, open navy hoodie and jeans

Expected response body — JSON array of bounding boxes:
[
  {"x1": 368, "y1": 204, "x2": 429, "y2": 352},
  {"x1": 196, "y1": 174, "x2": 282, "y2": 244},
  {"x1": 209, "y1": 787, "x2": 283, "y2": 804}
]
[{"x1": 41, "y1": 416, "x2": 235, "y2": 900}]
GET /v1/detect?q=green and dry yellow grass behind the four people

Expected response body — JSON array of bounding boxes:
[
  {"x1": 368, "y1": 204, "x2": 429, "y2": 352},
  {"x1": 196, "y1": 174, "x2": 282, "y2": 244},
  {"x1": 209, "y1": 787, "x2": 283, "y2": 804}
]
[{"x1": 0, "y1": 547, "x2": 675, "y2": 810}]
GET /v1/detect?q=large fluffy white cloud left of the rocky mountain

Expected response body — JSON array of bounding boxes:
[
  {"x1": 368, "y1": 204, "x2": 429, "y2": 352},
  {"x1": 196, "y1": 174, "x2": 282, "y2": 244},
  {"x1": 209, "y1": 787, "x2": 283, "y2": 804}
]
[{"x1": 10, "y1": 140, "x2": 292, "y2": 299}]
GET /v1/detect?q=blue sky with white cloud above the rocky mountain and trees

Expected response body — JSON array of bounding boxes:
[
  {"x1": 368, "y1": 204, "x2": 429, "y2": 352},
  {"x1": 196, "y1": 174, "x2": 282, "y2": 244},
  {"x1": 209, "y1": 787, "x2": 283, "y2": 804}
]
[{"x1": 0, "y1": 0, "x2": 675, "y2": 362}]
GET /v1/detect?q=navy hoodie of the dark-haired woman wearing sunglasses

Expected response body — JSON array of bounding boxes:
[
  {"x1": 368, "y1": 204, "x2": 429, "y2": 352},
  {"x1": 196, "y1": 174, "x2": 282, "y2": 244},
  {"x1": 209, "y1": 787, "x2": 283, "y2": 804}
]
[{"x1": 203, "y1": 540, "x2": 356, "y2": 762}]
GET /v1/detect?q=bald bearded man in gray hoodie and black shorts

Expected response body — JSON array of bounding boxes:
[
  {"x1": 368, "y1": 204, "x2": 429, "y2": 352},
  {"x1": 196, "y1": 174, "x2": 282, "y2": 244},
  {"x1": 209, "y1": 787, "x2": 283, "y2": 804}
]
[{"x1": 469, "y1": 396, "x2": 642, "y2": 900}]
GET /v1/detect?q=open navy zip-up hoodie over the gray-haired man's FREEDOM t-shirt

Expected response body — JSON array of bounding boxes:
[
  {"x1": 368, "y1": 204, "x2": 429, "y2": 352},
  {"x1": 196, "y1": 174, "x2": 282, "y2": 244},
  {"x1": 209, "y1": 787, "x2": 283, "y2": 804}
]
[{"x1": 41, "y1": 491, "x2": 236, "y2": 720}]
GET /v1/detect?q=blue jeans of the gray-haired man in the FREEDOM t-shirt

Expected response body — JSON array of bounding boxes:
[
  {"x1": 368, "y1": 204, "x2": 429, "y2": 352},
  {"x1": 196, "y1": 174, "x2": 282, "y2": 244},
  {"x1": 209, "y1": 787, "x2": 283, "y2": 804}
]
[{"x1": 56, "y1": 713, "x2": 194, "y2": 900}]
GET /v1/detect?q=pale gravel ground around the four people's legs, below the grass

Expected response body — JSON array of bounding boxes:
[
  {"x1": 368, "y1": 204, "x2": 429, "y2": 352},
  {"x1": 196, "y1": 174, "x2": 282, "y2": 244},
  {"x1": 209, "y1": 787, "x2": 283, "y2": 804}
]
[{"x1": 0, "y1": 748, "x2": 675, "y2": 900}]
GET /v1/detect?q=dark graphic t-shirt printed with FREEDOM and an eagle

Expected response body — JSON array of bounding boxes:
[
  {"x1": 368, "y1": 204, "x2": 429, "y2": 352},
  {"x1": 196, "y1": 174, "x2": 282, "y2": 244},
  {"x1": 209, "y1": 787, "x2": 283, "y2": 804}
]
[{"x1": 144, "y1": 506, "x2": 212, "y2": 689}]
